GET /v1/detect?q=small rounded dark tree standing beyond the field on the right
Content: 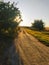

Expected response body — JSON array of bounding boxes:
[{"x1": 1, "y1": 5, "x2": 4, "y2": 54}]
[{"x1": 32, "y1": 20, "x2": 44, "y2": 30}]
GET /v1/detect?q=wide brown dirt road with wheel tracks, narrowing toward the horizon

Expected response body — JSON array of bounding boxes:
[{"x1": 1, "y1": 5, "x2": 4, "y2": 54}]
[{"x1": 15, "y1": 31, "x2": 49, "y2": 65}]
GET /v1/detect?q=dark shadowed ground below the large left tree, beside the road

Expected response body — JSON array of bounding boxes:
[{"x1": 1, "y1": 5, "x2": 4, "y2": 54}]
[{"x1": 0, "y1": 38, "x2": 23, "y2": 65}]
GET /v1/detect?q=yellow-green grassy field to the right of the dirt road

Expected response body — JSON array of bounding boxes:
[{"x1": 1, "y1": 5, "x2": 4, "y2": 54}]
[{"x1": 26, "y1": 28, "x2": 49, "y2": 46}]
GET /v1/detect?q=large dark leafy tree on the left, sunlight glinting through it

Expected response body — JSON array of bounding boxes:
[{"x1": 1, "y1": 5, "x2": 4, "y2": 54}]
[{"x1": 0, "y1": 2, "x2": 21, "y2": 36}]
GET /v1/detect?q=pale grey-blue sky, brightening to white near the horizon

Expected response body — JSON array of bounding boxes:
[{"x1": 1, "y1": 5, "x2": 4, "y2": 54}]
[{"x1": 4, "y1": 0, "x2": 49, "y2": 27}]
